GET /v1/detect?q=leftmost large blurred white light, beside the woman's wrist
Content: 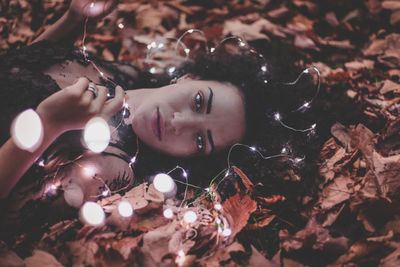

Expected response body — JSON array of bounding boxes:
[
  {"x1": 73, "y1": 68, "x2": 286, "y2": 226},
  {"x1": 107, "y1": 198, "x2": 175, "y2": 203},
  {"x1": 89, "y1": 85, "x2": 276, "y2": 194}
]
[{"x1": 11, "y1": 109, "x2": 43, "y2": 152}]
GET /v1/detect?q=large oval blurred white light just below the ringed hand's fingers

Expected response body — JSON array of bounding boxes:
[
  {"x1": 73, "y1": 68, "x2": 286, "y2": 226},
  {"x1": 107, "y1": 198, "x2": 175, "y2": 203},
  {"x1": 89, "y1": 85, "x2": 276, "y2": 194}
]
[{"x1": 83, "y1": 117, "x2": 111, "y2": 153}]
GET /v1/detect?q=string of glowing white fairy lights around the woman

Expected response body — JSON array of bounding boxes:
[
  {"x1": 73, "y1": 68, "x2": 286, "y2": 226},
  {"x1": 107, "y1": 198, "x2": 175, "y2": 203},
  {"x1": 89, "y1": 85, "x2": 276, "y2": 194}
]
[{"x1": 12, "y1": 2, "x2": 321, "y2": 263}]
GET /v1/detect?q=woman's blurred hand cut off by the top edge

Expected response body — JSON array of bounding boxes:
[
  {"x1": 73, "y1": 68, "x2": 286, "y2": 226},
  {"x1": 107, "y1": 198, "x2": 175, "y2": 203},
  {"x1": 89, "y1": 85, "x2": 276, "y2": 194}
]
[{"x1": 69, "y1": 0, "x2": 119, "y2": 19}]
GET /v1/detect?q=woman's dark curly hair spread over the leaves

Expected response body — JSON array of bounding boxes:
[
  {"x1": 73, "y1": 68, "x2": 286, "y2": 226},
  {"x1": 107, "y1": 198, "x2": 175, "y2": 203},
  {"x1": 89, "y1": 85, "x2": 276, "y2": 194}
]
[{"x1": 111, "y1": 44, "x2": 321, "y2": 203}]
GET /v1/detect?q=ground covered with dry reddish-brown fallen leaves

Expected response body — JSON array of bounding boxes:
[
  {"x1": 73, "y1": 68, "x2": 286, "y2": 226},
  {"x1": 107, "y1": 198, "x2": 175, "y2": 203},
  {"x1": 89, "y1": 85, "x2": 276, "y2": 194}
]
[{"x1": 0, "y1": 0, "x2": 400, "y2": 266}]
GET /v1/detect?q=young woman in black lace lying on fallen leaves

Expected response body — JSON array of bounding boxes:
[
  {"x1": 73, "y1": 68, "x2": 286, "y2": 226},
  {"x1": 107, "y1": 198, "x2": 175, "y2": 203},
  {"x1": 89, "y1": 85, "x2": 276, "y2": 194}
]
[{"x1": 0, "y1": 0, "x2": 322, "y2": 222}]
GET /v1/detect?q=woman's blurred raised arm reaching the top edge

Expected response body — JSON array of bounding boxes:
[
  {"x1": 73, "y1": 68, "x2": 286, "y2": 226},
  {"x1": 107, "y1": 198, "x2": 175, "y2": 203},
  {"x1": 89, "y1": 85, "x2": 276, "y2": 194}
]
[{"x1": 32, "y1": 0, "x2": 118, "y2": 43}]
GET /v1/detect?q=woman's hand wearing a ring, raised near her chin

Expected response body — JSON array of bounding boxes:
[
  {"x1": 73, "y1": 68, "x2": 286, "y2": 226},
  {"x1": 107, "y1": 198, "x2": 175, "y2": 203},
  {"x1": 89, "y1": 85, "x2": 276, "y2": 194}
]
[{"x1": 36, "y1": 78, "x2": 125, "y2": 136}]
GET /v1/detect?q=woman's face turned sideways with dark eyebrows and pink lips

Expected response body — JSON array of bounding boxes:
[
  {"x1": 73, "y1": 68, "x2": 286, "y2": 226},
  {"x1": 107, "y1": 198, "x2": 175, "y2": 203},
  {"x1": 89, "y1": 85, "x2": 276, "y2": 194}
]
[{"x1": 132, "y1": 78, "x2": 245, "y2": 156}]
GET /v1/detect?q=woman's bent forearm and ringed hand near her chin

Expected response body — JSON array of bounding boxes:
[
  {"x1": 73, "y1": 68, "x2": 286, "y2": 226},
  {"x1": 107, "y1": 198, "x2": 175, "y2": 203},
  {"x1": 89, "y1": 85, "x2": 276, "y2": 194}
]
[{"x1": 0, "y1": 78, "x2": 125, "y2": 198}]
